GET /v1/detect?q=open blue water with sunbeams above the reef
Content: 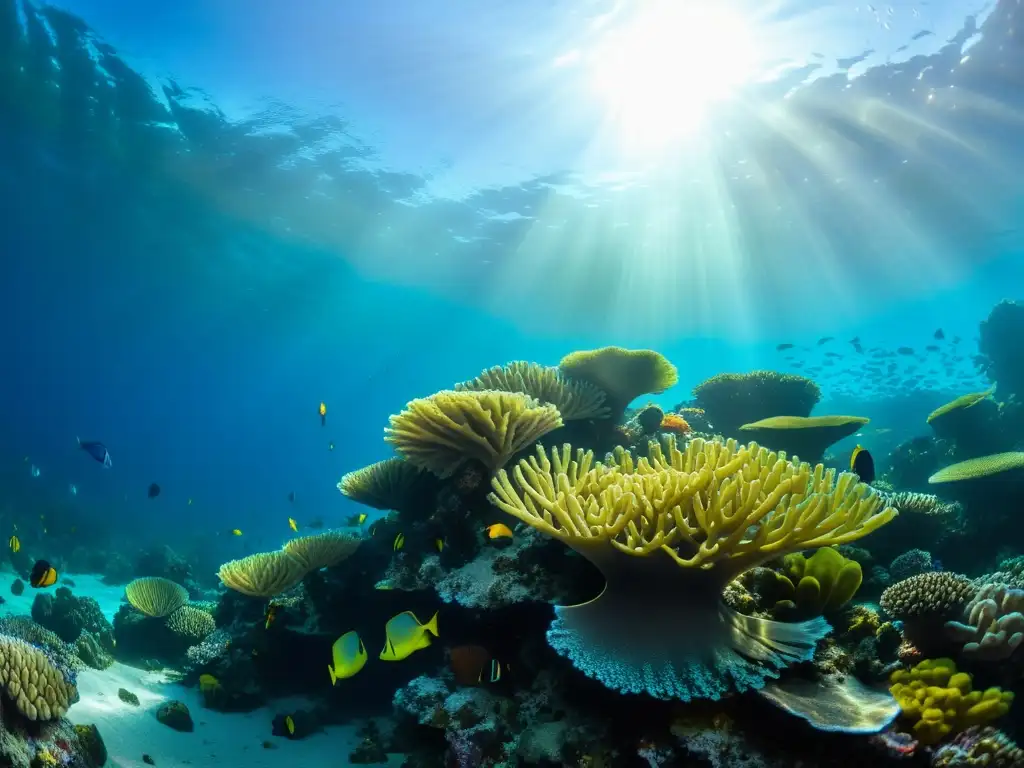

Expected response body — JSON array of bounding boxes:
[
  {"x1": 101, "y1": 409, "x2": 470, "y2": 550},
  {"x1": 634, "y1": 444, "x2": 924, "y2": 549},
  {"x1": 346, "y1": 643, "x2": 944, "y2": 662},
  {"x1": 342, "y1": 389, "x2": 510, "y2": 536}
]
[{"x1": 0, "y1": 0, "x2": 1024, "y2": 556}]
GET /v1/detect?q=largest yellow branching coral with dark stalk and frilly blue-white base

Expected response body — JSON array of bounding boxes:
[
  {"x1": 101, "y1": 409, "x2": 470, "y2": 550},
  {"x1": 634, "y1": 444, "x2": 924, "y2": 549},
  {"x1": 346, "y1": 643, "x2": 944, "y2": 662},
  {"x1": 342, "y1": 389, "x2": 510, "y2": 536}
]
[{"x1": 488, "y1": 438, "x2": 896, "y2": 699}]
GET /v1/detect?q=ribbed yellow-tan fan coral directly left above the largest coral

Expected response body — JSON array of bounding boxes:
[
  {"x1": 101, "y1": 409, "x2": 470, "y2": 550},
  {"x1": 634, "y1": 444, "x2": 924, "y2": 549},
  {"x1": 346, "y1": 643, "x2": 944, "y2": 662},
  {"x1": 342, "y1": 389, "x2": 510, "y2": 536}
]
[{"x1": 384, "y1": 390, "x2": 562, "y2": 477}]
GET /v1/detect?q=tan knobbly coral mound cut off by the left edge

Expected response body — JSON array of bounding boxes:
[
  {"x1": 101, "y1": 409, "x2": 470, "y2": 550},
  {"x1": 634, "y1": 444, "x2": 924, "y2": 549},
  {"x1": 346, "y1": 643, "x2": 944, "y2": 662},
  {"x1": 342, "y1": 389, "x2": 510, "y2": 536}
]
[{"x1": 0, "y1": 636, "x2": 78, "y2": 720}]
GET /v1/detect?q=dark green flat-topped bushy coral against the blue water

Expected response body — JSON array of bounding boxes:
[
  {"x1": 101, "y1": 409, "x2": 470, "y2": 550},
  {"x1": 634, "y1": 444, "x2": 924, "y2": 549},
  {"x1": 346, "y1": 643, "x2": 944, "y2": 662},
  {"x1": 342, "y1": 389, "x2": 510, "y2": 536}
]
[{"x1": 693, "y1": 371, "x2": 821, "y2": 436}]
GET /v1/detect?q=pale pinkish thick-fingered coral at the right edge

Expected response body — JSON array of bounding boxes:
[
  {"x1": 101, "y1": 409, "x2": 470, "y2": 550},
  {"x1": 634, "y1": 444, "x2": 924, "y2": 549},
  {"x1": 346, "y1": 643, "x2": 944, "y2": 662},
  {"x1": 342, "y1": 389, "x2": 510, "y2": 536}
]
[{"x1": 946, "y1": 584, "x2": 1024, "y2": 660}]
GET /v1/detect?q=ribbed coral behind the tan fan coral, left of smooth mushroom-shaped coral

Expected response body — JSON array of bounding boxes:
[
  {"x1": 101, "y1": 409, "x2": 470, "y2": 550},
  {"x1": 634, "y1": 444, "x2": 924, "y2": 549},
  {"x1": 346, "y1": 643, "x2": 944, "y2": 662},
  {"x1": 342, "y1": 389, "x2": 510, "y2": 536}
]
[{"x1": 455, "y1": 360, "x2": 609, "y2": 421}]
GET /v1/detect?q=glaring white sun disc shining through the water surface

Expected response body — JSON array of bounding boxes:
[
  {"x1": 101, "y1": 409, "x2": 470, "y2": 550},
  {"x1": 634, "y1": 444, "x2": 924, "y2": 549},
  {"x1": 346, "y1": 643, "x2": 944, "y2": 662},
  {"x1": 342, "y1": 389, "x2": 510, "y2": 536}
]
[{"x1": 590, "y1": 0, "x2": 758, "y2": 150}]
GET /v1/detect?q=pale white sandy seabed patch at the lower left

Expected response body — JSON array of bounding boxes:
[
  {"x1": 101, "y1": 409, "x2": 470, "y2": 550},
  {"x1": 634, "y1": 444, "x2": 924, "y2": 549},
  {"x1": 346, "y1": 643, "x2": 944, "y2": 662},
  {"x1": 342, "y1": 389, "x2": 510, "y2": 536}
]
[{"x1": 68, "y1": 664, "x2": 401, "y2": 768}]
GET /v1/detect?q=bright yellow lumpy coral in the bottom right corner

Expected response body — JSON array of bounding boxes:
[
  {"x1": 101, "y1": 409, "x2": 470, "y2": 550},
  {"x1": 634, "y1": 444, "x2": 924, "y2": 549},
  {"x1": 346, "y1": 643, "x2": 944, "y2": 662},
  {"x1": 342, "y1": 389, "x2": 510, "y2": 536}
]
[{"x1": 889, "y1": 658, "x2": 1014, "y2": 744}]
